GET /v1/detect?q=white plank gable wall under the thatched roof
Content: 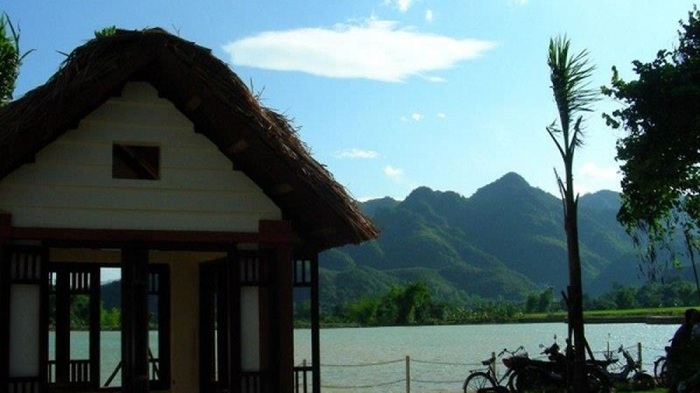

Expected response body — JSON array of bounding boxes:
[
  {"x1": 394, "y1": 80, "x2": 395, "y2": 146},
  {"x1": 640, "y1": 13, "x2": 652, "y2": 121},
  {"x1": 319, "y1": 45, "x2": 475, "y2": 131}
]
[{"x1": 0, "y1": 82, "x2": 281, "y2": 232}]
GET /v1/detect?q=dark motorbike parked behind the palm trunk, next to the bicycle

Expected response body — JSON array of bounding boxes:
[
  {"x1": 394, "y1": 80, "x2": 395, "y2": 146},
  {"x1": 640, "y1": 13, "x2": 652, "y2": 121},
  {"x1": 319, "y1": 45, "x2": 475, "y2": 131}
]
[{"x1": 503, "y1": 342, "x2": 610, "y2": 393}]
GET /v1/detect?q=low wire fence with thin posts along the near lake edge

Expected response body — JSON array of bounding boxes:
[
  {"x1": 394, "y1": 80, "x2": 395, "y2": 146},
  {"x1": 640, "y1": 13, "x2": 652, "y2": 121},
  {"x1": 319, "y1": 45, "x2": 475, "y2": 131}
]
[{"x1": 296, "y1": 343, "x2": 664, "y2": 393}]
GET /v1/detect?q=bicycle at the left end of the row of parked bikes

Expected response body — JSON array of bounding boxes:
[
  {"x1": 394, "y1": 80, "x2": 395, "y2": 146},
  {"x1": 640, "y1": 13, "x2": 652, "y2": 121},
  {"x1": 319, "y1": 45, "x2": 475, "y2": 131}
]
[{"x1": 462, "y1": 345, "x2": 527, "y2": 393}]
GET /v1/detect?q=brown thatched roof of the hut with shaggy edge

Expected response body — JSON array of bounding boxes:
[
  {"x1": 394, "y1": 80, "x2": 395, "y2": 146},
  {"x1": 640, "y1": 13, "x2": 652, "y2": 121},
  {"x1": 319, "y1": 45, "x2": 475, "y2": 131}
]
[{"x1": 0, "y1": 29, "x2": 378, "y2": 249}]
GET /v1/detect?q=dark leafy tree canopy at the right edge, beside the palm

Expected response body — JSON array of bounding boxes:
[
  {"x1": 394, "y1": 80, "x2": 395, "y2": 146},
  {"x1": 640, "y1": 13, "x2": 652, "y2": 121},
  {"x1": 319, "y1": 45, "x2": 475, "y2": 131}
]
[{"x1": 602, "y1": 7, "x2": 700, "y2": 278}]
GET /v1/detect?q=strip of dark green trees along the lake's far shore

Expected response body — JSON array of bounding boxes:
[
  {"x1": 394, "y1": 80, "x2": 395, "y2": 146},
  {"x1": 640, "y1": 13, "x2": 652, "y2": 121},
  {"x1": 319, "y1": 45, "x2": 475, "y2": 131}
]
[{"x1": 320, "y1": 280, "x2": 695, "y2": 326}]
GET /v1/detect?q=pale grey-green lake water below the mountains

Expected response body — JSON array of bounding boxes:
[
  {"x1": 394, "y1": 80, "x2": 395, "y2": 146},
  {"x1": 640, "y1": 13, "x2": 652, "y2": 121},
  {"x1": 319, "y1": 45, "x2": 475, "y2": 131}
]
[{"x1": 50, "y1": 323, "x2": 677, "y2": 393}]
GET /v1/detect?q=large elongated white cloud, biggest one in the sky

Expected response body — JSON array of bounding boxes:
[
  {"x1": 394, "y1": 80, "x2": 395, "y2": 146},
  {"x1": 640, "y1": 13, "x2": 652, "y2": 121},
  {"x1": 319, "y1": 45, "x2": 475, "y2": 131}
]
[{"x1": 223, "y1": 19, "x2": 496, "y2": 82}]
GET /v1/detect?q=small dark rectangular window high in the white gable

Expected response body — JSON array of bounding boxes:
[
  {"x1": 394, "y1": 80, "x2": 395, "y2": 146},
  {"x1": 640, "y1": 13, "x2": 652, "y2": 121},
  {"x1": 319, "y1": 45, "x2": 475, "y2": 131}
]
[{"x1": 112, "y1": 143, "x2": 160, "y2": 180}]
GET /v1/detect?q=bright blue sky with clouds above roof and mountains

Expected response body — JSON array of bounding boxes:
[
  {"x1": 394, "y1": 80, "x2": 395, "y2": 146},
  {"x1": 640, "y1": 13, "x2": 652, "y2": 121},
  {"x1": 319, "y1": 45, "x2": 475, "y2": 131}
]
[{"x1": 0, "y1": 0, "x2": 693, "y2": 200}]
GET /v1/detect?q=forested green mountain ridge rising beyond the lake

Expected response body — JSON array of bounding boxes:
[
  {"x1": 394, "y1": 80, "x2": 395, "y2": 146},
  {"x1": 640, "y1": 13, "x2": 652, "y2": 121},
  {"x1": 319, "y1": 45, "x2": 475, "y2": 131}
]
[{"x1": 320, "y1": 173, "x2": 652, "y2": 307}]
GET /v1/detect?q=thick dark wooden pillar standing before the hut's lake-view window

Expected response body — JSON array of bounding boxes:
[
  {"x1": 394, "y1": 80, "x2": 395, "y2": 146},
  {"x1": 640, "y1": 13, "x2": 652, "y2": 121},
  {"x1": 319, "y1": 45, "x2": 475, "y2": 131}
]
[{"x1": 121, "y1": 243, "x2": 148, "y2": 393}]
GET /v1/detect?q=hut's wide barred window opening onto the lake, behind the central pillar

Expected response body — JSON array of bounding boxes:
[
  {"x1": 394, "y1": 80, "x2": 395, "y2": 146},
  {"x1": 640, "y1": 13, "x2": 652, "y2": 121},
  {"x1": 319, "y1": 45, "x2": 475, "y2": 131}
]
[{"x1": 47, "y1": 263, "x2": 170, "y2": 391}]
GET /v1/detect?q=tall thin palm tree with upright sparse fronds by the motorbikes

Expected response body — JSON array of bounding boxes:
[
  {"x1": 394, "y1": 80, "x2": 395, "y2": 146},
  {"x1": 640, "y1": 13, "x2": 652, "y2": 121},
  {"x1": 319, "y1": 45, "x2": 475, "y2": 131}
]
[{"x1": 546, "y1": 37, "x2": 597, "y2": 392}]
